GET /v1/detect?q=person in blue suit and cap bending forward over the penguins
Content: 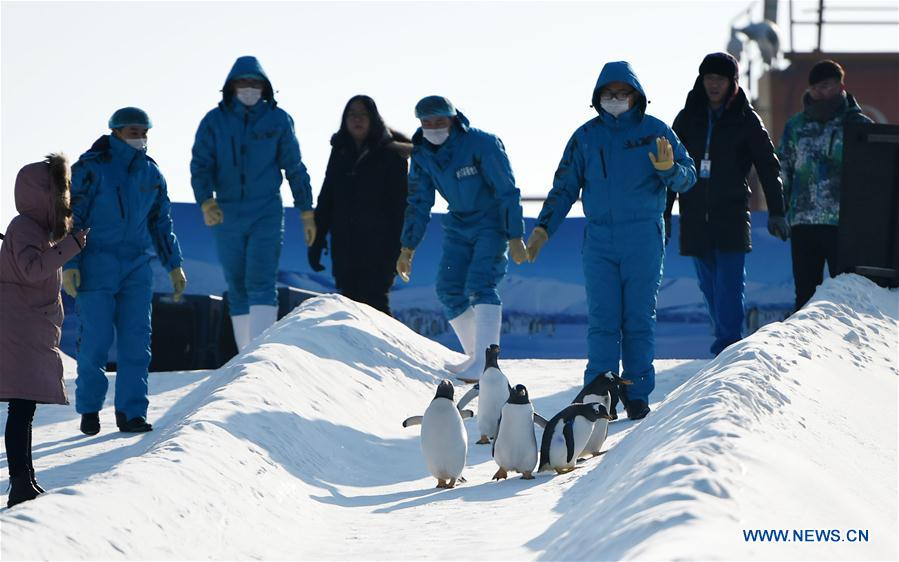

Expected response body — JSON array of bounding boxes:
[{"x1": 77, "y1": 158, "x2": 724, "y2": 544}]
[{"x1": 396, "y1": 96, "x2": 527, "y2": 382}]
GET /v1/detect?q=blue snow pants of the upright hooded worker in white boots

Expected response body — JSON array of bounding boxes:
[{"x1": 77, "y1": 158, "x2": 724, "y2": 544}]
[{"x1": 212, "y1": 198, "x2": 284, "y2": 316}]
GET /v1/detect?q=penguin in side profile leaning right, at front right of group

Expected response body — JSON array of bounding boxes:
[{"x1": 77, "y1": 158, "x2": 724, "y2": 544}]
[{"x1": 540, "y1": 404, "x2": 609, "y2": 474}]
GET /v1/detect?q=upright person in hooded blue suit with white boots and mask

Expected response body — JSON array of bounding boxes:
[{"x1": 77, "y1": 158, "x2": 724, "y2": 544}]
[{"x1": 190, "y1": 56, "x2": 315, "y2": 350}]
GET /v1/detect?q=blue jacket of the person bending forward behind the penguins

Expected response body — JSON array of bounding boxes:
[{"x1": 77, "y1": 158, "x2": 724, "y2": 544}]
[{"x1": 401, "y1": 112, "x2": 524, "y2": 248}]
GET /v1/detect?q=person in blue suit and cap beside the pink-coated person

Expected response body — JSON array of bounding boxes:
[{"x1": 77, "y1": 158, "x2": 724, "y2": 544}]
[{"x1": 63, "y1": 107, "x2": 187, "y2": 435}]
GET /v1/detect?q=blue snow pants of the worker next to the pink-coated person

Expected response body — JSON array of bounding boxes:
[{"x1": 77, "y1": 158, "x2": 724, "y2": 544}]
[{"x1": 75, "y1": 249, "x2": 153, "y2": 420}]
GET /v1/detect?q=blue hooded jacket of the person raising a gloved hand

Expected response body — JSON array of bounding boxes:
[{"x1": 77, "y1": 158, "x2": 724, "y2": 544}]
[{"x1": 537, "y1": 61, "x2": 696, "y2": 235}]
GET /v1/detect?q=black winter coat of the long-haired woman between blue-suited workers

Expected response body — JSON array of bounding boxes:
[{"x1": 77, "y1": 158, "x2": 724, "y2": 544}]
[{"x1": 310, "y1": 133, "x2": 408, "y2": 285}]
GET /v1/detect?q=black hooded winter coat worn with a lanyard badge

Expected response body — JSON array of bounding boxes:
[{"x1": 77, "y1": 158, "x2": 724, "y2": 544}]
[{"x1": 665, "y1": 85, "x2": 784, "y2": 257}]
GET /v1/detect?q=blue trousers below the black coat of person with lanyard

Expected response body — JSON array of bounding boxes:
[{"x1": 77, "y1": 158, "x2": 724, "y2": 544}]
[{"x1": 693, "y1": 250, "x2": 746, "y2": 355}]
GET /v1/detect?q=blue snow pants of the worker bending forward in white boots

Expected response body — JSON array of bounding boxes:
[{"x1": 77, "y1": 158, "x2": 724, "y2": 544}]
[{"x1": 437, "y1": 215, "x2": 509, "y2": 320}]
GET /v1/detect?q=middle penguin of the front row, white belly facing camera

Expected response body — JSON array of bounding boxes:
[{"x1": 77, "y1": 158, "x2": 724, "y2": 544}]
[{"x1": 496, "y1": 379, "x2": 537, "y2": 480}]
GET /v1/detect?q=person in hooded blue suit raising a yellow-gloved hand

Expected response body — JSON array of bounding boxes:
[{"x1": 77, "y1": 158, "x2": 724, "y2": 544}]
[{"x1": 528, "y1": 61, "x2": 696, "y2": 419}]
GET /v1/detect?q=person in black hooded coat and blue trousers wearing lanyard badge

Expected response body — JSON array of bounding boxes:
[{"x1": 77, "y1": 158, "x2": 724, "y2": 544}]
[{"x1": 665, "y1": 53, "x2": 789, "y2": 355}]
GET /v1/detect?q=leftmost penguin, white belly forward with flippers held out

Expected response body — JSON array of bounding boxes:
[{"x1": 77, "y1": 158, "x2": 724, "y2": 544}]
[{"x1": 403, "y1": 379, "x2": 472, "y2": 488}]
